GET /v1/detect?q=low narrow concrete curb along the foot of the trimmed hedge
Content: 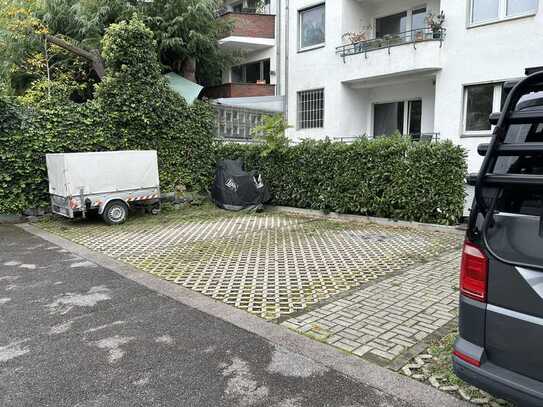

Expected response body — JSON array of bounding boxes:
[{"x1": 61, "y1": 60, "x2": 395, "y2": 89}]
[{"x1": 266, "y1": 205, "x2": 466, "y2": 236}]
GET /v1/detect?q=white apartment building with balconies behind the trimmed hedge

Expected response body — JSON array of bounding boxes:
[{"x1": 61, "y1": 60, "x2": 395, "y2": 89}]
[{"x1": 209, "y1": 0, "x2": 543, "y2": 172}]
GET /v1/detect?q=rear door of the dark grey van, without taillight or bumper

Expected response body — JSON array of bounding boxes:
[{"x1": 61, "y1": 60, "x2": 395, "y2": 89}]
[{"x1": 483, "y1": 112, "x2": 543, "y2": 381}]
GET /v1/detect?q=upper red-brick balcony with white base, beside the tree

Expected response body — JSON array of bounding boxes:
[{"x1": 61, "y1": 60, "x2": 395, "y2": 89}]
[{"x1": 219, "y1": 12, "x2": 275, "y2": 52}]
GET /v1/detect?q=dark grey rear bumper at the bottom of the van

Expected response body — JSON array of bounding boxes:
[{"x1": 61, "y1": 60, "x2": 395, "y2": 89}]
[{"x1": 453, "y1": 350, "x2": 543, "y2": 407}]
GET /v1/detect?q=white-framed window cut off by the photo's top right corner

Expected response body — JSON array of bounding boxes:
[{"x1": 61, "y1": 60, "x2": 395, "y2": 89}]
[{"x1": 469, "y1": 0, "x2": 538, "y2": 24}]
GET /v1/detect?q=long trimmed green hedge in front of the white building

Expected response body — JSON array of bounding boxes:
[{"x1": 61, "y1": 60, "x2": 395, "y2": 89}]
[{"x1": 217, "y1": 137, "x2": 466, "y2": 224}]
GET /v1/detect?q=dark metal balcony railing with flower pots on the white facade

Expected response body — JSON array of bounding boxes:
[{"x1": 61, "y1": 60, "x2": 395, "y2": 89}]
[{"x1": 336, "y1": 27, "x2": 446, "y2": 59}]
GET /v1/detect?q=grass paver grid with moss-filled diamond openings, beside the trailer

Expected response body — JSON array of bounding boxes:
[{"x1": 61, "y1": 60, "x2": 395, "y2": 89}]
[{"x1": 41, "y1": 208, "x2": 460, "y2": 320}]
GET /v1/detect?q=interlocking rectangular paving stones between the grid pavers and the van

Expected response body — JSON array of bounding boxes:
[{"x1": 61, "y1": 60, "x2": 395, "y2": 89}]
[{"x1": 283, "y1": 252, "x2": 460, "y2": 364}]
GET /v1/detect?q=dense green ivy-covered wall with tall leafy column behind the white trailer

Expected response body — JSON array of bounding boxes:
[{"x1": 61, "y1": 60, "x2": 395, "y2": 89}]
[{"x1": 0, "y1": 19, "x2": 215, "y2": 213}]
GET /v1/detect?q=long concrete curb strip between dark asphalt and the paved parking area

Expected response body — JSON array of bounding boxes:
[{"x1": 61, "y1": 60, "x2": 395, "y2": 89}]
[{"x1": 18, "y1": 224, "x2": 469, "y2": 407}]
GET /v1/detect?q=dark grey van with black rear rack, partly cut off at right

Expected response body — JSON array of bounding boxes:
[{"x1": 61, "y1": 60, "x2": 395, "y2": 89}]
[{"x1": 453, "y1": 68, "x2": 543, "y2": 406}]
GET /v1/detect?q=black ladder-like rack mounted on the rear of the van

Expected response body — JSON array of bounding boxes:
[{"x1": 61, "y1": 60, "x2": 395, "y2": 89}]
[{"x1": 469, "y1": 68, "x2": 543, "y2": 225}]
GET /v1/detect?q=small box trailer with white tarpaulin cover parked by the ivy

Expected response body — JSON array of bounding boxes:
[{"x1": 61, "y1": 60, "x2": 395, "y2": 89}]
[{"x1": 46, "y1": 151, "x2": 160, "y2": 225}]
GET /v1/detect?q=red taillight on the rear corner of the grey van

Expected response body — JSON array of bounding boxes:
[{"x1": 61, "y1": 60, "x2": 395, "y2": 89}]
[{"x1": 460, "y1": 241, "x2": 488, "y2": 302}]
